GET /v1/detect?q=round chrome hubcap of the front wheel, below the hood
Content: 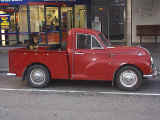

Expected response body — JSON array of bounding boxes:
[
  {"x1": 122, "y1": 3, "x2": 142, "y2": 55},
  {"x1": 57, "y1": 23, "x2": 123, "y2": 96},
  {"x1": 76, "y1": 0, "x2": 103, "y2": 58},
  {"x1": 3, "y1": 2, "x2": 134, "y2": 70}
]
[{"x1": 120, "y1": 70, "x2": 138, "y2": 88}]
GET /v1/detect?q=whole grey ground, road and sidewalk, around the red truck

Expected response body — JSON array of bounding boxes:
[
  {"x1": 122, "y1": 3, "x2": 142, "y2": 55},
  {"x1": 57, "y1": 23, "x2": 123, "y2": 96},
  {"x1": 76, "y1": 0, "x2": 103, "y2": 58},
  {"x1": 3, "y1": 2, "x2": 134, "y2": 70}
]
[{"x1": 0, "y1": 45, "x2": 160, "y2": 120}]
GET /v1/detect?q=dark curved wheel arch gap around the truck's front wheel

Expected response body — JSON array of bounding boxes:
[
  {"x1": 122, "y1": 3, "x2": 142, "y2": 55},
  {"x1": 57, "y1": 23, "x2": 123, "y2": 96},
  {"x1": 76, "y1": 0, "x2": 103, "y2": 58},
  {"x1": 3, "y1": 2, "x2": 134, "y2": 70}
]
[{"x1": 112, "y1": 64, "x2": 143, "y2": 86}]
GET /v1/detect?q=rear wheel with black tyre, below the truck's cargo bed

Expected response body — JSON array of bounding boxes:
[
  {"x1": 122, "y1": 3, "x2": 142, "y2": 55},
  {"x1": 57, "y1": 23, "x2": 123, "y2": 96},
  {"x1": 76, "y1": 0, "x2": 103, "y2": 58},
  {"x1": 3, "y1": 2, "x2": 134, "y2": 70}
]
[{"x1": 26, "y1": 65, "x2": 50, "y2": 88}]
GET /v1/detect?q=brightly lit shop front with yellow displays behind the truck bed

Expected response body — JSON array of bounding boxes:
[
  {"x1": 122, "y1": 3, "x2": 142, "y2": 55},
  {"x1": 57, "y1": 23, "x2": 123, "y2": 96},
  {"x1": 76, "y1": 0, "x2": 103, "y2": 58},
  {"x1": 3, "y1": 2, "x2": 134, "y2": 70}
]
[{"x1": 0, "y1": 0, "x2": 90, "y2": 46}]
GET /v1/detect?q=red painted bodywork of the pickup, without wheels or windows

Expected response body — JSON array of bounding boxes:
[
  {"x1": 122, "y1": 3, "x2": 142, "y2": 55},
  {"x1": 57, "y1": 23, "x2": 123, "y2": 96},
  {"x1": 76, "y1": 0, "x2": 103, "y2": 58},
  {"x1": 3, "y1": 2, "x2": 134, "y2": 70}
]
[{"x1": 9, "y1": 28, "x2": 152, "y2": 80}]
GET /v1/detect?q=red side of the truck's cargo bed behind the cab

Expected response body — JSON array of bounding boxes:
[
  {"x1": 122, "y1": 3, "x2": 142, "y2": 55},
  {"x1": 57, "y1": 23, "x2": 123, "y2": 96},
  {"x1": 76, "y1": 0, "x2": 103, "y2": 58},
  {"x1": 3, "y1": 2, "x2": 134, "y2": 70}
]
[{"x1": 9, "y1": 47, "x2": 69, "y2": 79}]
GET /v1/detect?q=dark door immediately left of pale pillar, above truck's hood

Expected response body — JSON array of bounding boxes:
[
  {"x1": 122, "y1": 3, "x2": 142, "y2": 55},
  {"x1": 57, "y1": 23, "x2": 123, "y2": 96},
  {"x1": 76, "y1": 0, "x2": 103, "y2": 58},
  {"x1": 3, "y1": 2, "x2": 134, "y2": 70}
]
[{"x1": 109, "y1": 0, "x2": 126, "y2": 41}]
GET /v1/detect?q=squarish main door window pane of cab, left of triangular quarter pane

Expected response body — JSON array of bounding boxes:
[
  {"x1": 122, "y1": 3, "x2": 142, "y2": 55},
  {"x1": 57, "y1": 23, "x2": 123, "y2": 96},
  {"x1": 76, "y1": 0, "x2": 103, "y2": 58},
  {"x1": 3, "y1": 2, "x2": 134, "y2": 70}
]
[{"x1": 77, "y1": 34, "x2": 91, "y2": 49}]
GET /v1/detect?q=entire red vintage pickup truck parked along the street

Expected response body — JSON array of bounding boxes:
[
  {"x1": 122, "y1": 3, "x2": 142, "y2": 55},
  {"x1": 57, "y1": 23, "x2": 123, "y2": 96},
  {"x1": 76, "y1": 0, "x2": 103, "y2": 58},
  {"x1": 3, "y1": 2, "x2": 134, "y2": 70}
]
[{"x1": 9, "y1": 28, "x2": 157, "y2": 90}]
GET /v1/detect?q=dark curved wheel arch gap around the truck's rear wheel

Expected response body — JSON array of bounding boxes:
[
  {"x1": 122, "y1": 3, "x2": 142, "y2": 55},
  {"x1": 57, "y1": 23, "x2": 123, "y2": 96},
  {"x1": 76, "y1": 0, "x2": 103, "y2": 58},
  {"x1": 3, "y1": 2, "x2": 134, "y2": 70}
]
[{"x1": 22, "y1": 63, "x2": 51, "y2": 80}]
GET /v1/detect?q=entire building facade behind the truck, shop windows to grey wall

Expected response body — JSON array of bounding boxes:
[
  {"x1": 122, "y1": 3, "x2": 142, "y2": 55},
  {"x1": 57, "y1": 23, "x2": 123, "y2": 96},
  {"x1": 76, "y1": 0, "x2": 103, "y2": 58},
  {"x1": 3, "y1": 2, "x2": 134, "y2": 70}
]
[{"x1": 0, "y1": 0, "x2": 160, "y2": 46}]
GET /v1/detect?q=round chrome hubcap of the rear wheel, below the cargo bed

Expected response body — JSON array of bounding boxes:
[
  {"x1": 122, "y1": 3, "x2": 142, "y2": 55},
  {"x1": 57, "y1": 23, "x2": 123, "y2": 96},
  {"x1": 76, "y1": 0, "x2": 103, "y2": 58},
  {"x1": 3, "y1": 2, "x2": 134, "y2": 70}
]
[{"x1": 30, "y1": 69, "x2": 46, "y2": 85}]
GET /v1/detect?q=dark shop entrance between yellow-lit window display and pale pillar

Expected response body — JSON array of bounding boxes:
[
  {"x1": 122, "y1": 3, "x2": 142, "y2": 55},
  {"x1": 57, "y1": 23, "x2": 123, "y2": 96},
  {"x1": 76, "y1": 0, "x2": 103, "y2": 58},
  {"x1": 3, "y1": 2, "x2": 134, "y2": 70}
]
[{"x1": 91, "y1": 0, "x2": 128, "y2": 43}]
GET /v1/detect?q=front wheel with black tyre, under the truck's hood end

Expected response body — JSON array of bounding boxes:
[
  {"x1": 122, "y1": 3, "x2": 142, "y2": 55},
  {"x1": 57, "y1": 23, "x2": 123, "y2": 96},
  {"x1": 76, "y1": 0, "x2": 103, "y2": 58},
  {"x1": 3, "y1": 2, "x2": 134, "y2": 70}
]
[{"x1": 116, "y1": 66, "x2": 142, "y2": 91}]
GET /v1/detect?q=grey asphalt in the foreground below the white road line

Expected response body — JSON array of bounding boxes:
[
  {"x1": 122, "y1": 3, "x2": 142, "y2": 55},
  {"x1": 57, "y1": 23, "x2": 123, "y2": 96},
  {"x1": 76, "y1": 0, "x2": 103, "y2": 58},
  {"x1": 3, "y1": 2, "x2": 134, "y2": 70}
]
[{"x1": 0, "y1": 91, "x2": 160, "y2": 120}]
